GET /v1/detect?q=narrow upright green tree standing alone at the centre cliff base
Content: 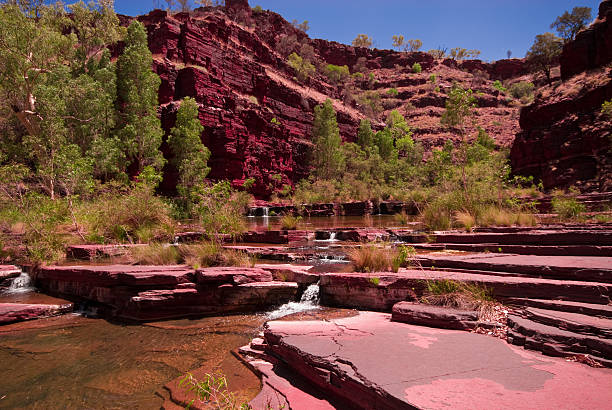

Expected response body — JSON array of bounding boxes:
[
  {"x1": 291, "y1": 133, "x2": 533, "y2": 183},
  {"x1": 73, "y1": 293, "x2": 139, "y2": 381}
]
[{"x1": 312, "y1": 99, "x2": 344, "y2": 179}]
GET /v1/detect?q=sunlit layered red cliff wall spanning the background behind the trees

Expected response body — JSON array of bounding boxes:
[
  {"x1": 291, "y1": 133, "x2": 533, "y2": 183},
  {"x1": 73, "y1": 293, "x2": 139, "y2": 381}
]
[{"x1": 128, "y1": 0, "x2": 530, "y2": 198}]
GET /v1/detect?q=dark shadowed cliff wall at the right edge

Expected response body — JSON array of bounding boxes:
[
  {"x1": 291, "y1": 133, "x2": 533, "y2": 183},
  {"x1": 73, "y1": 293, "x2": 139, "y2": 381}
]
[{"x1": 511, "y1": 0, "x2": 612, "y2": 191}]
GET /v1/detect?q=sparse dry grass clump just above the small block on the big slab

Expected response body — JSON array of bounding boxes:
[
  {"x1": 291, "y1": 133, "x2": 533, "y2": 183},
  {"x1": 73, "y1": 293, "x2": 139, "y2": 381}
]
[{"x1": 420, "y1": 279, "x2": 493, "y2": 310}]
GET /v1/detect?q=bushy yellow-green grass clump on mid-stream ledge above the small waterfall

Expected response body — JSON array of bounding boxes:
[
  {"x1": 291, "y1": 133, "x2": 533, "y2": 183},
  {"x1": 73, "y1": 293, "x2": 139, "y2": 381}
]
[{"x1": 348, "y1": 245, "x2": 414, "y2": 272}]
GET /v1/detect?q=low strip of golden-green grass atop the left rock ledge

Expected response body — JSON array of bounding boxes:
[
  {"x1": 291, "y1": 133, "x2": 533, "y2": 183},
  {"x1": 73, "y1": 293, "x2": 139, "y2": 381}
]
[{"x1": 130, "y1": 242, "x2": 253, "y2": 269}]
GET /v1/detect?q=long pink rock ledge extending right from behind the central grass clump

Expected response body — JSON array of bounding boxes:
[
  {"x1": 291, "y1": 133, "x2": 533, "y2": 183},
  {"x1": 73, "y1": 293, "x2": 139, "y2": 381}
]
[{"x1": 418, "y1": 253, "x2": 612, "y2": 282}]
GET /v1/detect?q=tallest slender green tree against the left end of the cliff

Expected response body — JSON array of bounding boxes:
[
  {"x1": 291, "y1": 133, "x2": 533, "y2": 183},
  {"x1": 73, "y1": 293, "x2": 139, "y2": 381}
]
[{"x1": 117, "y1": 21, "x2": 165, "y2": 178}]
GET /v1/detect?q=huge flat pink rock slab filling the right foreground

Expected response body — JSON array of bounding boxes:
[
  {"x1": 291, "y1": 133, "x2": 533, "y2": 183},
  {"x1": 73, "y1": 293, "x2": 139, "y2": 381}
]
[{"x1": 265, "y1": 312, "x2": 612, "y2": 409}]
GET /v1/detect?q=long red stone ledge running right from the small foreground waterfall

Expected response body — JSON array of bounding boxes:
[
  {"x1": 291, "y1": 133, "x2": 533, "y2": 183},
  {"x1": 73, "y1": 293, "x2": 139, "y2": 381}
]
[{"x1": 320, "y1": 269, "x2": 612, "y2": 312}]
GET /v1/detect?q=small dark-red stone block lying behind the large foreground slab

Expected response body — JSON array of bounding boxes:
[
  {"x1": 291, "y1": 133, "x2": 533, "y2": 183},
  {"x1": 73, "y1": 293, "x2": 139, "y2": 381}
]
[{"x1": 391, "y1": 302, "x2": 478, "y2": 330}]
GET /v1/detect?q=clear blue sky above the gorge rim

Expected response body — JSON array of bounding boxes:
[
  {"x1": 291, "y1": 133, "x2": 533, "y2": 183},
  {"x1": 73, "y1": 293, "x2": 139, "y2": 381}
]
[{"x1": 115, "y1": 0, "x2": 600, "y2": 60}]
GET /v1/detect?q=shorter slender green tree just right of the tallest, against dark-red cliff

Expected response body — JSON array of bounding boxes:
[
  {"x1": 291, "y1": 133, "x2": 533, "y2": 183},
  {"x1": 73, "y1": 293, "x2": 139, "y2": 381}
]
[{"x1": 168, "y1": 97, "x2": 210, "y2": 202}]
